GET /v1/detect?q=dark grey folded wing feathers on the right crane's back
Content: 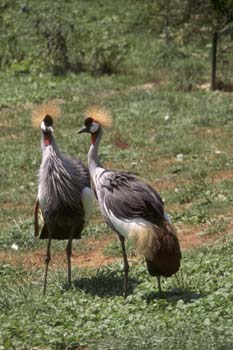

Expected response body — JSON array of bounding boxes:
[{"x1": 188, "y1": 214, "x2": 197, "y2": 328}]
[{"x1": 95, "y1": 169, "x2": 164, "y2": 224}]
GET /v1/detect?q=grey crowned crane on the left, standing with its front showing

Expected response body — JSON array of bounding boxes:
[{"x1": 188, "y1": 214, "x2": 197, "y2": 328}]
[{"x1": 32, "y1": 103, "x2": 93, "y2": 293}]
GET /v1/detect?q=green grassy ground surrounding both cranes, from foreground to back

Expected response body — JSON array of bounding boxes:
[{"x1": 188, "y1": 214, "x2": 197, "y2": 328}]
[{"x1": 0, "y1": 0, "x2": 233, "y2": 350}]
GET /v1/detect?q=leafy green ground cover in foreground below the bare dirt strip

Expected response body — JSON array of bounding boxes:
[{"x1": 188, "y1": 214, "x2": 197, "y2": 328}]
[{"x1": 0, "y1": 239, "x2": 233, "y2": 350}]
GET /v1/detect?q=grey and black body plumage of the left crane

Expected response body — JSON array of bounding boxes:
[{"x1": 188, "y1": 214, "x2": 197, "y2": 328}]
[{"x1": 38, "y1": 139, "x2": 90, "y2": 239}]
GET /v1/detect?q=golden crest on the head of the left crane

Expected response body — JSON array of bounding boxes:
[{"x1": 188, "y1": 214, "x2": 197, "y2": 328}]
[{"x1": 32, "y1": 101, "x2": 61, "y2": 128}]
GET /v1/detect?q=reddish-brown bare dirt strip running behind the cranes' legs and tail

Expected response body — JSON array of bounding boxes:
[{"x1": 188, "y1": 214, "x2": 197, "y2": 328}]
[{"x1": 0, "y1": 224, "x2": 233, "y2": 270}]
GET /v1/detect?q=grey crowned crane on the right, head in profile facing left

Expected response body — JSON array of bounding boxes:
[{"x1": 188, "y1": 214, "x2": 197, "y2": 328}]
[{"x1": 78, "y1": 108, "x2": 181, "y2": 297}]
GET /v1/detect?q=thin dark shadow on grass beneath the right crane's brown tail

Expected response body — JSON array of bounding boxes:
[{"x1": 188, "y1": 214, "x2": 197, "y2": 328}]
[{"x1": 146, "y1": 288, "x2": 204, "y2": 303}]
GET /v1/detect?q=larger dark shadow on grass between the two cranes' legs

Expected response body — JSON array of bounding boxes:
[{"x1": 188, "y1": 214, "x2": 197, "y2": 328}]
[{"x1": 74, "y1": 270, "x2": 139, "y2": 297}]
